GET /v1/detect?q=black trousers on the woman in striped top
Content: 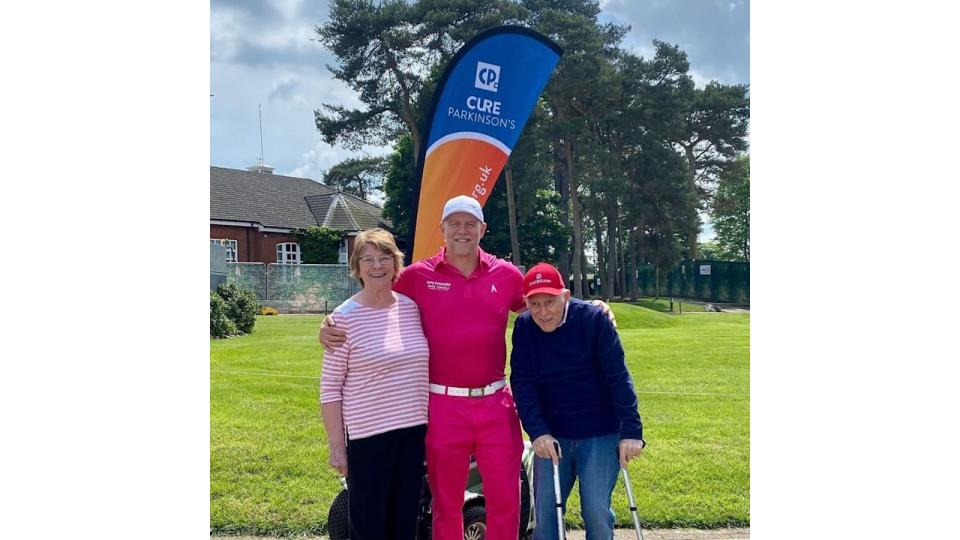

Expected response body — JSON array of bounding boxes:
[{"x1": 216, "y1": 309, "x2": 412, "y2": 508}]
[{"x1": 347, "y1": 425, "x2": 427, "y2": 540}]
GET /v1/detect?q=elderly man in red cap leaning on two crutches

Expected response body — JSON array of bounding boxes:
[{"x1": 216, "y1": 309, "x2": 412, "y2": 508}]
[{"x1": 510, "y1": 263, "x2": 646, "y2": 540}]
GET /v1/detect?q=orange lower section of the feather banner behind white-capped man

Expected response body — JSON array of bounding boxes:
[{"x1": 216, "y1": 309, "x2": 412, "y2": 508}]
[{"x1": 413, "y1": 138, "x2": 509, "y2": 262}]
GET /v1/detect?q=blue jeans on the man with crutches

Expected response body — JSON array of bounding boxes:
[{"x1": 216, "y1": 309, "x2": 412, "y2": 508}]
[{"x1": 533, "y1": 433, "x2": 620, "y2": 540}]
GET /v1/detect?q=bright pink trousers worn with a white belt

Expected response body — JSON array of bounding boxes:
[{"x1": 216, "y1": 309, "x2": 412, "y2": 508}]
[{"x1": 426, "y1": 388, "x2": 523, "y2": 540}]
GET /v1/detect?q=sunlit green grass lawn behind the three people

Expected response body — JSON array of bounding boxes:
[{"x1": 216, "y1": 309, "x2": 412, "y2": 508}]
[{"x1": 210, "y1": 306, "x2": 750, "y2": 535}]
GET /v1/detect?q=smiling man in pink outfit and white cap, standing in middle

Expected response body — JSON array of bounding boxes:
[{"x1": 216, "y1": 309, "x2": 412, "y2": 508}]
[{"x1": 320, "y1": 195, "x2": 525, "y2": 540}]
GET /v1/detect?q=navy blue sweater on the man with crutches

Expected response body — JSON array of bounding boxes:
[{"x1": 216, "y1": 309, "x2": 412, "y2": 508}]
[{"x1": 510, "y1": 298, "x2": 643, "y2": 440}]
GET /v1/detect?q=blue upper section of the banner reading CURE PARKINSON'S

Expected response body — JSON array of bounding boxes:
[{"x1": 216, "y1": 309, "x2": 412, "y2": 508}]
[{"x1": 427, "y1": 33, "x2": 560, "y2": 149}]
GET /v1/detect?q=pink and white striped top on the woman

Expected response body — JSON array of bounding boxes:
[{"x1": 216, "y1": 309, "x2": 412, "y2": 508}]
[{"x1": 320, "y1": 293, "x2": 430, "y2": 439}]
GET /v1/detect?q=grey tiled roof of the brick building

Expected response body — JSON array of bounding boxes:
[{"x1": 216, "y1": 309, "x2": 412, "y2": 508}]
[{"x1": 210, "y1": 166, "x2": 390, "y2": 231}]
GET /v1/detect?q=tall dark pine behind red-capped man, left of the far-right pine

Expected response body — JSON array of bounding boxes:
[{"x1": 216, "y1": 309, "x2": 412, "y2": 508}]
[{"x1": 587, "y1": 41, "x2": 695, "y2": 298}]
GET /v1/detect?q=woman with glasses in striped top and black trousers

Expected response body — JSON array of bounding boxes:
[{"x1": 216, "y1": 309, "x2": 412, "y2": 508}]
[{"x1": 320, "y1": 229, "x2": 429, "y2": 540}]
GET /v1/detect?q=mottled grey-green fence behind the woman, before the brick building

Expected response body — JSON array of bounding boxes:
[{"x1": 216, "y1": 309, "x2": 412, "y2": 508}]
[{"x1": 227, "y1": 263, "x2": 360, "y2": 313}]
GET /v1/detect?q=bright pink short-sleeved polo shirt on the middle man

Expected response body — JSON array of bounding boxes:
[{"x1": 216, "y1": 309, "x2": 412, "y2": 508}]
[{"x1": 393, "y1": 248, "x2": 524, "y2": 387}]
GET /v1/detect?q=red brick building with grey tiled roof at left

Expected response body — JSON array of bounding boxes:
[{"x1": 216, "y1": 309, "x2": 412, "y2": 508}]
[{"x1": 210, "y1": 165, "x2": 390, "y2": 264}]
